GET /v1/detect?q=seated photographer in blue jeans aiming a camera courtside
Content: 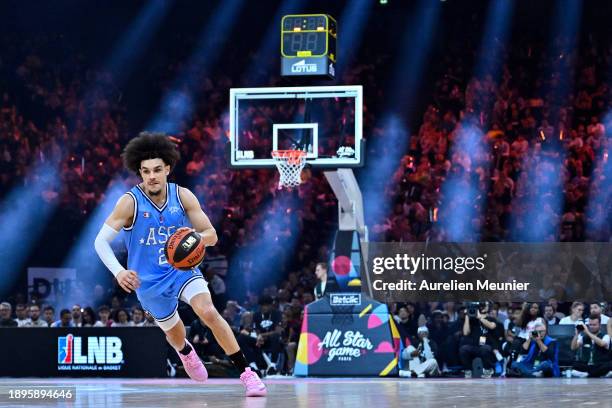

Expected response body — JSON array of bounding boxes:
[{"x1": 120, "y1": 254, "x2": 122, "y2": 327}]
[{"x1": 511, "y1": 321, "x2": 560, "y2": 377}]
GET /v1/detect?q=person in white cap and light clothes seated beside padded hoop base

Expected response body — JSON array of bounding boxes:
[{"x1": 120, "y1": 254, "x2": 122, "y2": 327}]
[{"x1": 399, "y1": 326, "x2": 440, "y2": 378}]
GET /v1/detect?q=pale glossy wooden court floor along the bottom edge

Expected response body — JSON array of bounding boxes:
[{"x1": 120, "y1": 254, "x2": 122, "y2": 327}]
[{"x1": 0, "y1": 378, "x2": 612, "y2": 408}]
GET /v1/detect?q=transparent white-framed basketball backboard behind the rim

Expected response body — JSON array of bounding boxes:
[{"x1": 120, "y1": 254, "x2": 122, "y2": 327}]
[{"x1": 229, "y1": 85, "x2": 364, "y2": 168}]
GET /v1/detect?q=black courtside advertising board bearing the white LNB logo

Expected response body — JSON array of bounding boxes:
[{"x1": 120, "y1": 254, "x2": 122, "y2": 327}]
[{"x1": 0, "y1": 327, "x2": 167, "y2": 378}]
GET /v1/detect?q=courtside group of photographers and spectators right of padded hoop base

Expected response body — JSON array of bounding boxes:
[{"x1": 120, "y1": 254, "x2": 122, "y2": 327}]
[{"x1": 395, "y1": 299, "x2": 612, "y2": 378}]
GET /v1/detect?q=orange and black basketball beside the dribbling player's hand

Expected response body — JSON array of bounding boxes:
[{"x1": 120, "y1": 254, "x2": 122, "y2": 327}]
[{"x1": 164, "y1": 228, "x2": 205, "y2": 270}]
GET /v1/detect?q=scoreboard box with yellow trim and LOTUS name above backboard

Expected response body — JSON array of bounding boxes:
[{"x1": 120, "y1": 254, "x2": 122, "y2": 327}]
[{"x1": 281, "y1": 14, "x2": 337, "y2": 78}]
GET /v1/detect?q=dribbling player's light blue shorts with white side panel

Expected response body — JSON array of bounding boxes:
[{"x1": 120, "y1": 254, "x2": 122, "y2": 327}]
[{"x1": 136, "y1": 270, "x2": 210, "y2": 323}]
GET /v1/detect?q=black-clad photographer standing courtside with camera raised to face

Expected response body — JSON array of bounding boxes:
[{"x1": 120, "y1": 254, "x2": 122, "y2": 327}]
[{"x1": 459, "y1": 303, "x2": 499, "y2": 378}]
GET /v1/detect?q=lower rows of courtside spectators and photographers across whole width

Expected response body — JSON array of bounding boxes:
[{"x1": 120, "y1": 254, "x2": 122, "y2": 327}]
[{"x1": 0, "y1": 294, "x2": 612, "y2": 378}]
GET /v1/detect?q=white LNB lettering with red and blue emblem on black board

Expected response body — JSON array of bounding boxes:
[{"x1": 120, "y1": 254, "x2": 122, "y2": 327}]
[{"x1": 57, "y1": 334, "x2": 123, "y2": 370}]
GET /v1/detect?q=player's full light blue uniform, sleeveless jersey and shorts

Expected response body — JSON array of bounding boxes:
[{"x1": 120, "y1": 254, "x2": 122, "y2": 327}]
[{"x1": 124, "y1": 183, "x2": 204, "y2": 322}]
